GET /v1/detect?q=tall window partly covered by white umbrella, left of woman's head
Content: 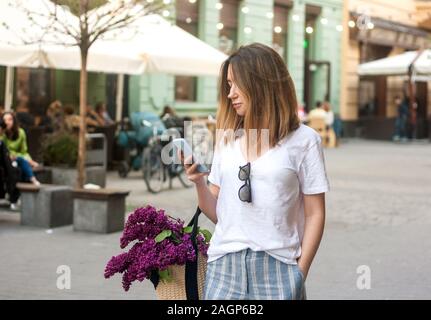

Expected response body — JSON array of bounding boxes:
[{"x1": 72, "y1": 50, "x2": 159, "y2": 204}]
[{"x1": 175, "y1": 0, "x2": 199, "y2": 101}]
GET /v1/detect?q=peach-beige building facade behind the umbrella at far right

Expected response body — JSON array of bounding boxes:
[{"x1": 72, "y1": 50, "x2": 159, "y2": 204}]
[{"x1": 340, "y1": 0, "x2": 431, "y2": 140}]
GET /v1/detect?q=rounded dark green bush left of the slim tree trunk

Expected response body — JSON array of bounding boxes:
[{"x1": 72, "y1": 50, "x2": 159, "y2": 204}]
[{"x1": 42, "y1": 131, "x2": 78, "y2": 168}]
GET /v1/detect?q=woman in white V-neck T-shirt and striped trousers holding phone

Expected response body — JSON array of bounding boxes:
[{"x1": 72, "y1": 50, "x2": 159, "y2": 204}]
[{"x1": 183, "y1": 44, "x2": 329, "y2": 299}]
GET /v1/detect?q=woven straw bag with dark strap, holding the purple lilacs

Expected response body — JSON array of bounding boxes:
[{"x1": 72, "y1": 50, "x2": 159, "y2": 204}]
[{"x1": 150, "y1": 207, "x2": 207, "y2": 300}]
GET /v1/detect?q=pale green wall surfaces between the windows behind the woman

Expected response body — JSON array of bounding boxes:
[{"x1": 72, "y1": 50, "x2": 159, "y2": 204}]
[{"x1": 129, "y1": 0, "x2": 343, "y2": 115}]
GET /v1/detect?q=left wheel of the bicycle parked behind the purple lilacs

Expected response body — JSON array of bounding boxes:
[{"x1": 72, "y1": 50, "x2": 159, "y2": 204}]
[{"x1": 142, "y1": 146, "x2": 166, "y2": 193}]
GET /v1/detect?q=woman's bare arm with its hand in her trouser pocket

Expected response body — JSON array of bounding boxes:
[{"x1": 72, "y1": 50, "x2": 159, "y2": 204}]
[{"x1": 298, "y1": 193, "x2": 325, "y2": 279}]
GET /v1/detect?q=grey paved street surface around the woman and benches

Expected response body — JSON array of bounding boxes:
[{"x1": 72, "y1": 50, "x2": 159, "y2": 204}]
[{"x1": 0, "y1": 139, "x2": 431, "y2": 299}]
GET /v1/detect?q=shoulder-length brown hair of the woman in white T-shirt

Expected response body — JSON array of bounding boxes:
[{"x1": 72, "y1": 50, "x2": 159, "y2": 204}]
[{"x1": 217, "y1": 43, "x2": 300, "y2": 150}]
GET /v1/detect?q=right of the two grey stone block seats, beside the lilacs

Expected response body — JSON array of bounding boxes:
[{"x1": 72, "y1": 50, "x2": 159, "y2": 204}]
[{"x1": 73, "y1": 189, "x2": 129, "y2": 233}]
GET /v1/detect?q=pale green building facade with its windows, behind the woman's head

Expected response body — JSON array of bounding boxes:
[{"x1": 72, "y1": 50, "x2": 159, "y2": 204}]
[{"x1": 129, "y1": 0, "x2": 343, "y2": 119}]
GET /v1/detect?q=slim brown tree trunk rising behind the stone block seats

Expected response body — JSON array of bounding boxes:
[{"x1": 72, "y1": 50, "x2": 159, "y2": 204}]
[{"x1": 77, "y1": 49, "x2": 88, "y2": 188}]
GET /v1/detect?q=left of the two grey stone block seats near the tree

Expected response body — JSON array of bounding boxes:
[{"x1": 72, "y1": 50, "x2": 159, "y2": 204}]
[{"x1": 17, "y1": 183, "x2": 73, "y2": 228}]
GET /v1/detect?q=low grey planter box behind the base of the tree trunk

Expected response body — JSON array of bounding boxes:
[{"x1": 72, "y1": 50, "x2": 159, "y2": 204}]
[{"x1": 50, "y1": 167, "x2": 106, "y2": 188}]
